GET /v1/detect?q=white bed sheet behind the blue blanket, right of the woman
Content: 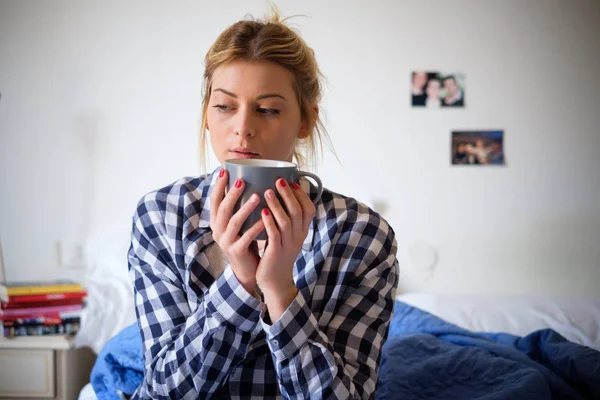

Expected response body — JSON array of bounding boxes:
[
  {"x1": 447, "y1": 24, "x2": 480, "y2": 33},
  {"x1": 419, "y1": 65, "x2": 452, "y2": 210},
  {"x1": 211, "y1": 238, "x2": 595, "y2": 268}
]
[{"x1": 397, "y1": 293, "x2": 600, "y2": 351}]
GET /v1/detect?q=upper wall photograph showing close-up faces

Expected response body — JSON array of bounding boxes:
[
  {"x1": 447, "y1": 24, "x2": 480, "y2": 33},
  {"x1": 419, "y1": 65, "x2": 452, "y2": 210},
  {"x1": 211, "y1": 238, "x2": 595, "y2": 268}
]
[{"x1": 410, "y1": 71, "x2": 465, "y2": 108}]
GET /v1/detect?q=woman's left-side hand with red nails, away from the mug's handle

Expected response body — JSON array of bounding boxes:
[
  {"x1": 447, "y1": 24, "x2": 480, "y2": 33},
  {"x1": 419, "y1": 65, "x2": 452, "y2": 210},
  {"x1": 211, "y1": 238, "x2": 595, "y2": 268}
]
[{"x1": 210, "y1": 169, "x2": 264, "y2": 294}]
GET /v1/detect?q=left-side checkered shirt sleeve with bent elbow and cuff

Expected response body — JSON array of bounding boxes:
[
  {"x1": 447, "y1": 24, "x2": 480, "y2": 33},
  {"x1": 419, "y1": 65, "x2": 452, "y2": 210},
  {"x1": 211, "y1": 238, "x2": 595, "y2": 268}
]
[{"x1": 128, "y1": 198, "x2": 264, "y2": 399}]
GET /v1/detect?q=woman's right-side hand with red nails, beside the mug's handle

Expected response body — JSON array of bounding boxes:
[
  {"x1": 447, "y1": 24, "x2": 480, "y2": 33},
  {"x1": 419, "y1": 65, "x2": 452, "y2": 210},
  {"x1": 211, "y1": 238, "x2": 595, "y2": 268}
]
[{"x1": 256, "y1": 179, "x2": 315, "y2": 322}]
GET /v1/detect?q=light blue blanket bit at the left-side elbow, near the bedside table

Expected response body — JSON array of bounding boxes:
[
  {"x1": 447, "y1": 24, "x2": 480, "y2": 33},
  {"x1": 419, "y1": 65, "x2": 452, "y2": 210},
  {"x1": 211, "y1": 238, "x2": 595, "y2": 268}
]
[{"x1": 90, "y1": 324, "x2": 144, "y2": 400}]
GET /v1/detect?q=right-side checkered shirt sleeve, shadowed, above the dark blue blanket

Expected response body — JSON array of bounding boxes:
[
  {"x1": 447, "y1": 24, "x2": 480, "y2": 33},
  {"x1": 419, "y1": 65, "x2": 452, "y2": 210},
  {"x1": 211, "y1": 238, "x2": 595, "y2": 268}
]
[{"x1": 261, "y1": 219, "x2": 398, "y2": 399}]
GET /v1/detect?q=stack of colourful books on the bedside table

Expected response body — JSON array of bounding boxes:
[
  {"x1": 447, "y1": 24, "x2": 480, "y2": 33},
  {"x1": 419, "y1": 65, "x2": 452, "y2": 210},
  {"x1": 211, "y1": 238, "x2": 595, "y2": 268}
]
[{"x1": 0, "y1": 280, "x2": 87, "y2": 337}]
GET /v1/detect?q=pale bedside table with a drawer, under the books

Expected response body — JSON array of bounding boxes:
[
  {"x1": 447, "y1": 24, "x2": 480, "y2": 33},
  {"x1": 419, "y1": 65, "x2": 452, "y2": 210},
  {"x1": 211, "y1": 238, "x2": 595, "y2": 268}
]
[{"x1": 0, "y1": 335, "x2": 96, "y2": 400}]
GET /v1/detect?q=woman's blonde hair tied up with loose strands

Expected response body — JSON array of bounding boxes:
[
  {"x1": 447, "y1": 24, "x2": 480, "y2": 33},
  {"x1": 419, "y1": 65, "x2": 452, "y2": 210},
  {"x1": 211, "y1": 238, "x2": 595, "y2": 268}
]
[{"x1": 200, "y1": 4, "x2": 335, "y2": 170}]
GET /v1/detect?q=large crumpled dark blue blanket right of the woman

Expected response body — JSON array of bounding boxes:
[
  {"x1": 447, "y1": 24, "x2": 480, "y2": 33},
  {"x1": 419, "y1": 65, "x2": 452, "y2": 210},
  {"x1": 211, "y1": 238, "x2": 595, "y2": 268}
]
[{"x1": 377, "y1": 301, "x2": 600, "y2": 400}]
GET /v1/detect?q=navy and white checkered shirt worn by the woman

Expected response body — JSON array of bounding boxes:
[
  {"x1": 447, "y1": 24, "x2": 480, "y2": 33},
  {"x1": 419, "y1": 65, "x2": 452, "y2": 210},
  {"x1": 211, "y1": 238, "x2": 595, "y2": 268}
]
[{"x1": 128, "y1": 172, "x2": 398, "y2": 399}]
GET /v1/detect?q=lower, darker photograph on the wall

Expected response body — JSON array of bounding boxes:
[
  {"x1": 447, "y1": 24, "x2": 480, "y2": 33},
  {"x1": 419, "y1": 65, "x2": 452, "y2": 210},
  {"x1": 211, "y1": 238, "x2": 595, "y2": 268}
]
[{"x1": 451, "y1": 130, "x2": 505, "y2": 165}]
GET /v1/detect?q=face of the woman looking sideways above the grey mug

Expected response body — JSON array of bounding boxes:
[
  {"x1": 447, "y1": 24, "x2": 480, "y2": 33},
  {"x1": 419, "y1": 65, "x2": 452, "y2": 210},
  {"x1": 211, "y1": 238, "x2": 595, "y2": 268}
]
[{"x1": 207, "y1": 61, "x2": 308, "y2": 164}]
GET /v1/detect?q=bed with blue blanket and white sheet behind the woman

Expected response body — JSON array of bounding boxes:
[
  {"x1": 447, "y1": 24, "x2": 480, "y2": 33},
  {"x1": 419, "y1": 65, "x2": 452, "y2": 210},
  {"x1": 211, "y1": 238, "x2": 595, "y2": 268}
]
[{"x1": 79, "y1": 294, "x2": 600, "y2": 400}]
